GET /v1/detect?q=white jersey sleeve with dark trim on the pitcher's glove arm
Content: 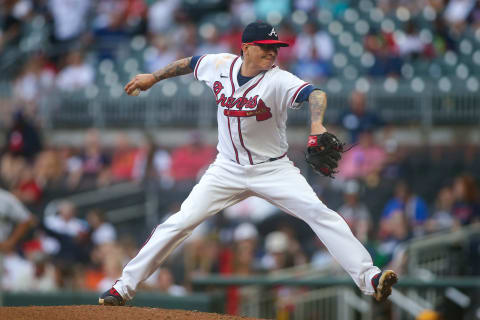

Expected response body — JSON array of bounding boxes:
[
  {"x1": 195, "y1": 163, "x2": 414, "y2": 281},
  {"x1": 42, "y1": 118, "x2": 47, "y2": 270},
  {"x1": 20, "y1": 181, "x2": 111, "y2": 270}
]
[{"x1": 276, "y1": 70, "x2": 313, "y2": 109}]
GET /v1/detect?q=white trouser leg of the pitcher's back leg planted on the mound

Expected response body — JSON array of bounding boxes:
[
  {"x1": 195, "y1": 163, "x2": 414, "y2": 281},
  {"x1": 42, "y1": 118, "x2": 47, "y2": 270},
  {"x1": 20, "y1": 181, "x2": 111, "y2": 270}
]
[{"x1": 114, "y1": 162, "x2": 245, "y2": 300}]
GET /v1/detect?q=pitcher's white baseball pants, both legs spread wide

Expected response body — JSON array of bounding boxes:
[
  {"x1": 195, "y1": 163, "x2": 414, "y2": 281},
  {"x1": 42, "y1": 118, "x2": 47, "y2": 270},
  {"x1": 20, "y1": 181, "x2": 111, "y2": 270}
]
[{"x1": 114, "y1": 155, "x2": 380, "y2": 300}]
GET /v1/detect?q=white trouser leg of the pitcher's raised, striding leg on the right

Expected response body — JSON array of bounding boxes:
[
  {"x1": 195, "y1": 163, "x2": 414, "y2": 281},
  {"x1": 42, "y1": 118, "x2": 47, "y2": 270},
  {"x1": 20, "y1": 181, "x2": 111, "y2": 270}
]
[{"x1": 252, "y1": 161, "x2": 380, "y2": 295}]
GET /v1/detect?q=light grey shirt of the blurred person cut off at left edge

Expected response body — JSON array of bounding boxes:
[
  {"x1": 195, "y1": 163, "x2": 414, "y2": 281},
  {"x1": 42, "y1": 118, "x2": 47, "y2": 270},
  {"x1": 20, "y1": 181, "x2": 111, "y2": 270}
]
[{"x1": 0, "y1": 189, "x2": 30, "y2": 242}]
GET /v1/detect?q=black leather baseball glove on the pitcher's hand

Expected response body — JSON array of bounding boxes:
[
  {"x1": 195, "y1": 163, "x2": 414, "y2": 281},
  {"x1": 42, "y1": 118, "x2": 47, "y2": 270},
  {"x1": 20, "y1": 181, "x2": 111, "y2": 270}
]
[{"x1": 305, "y1": 132, "x2": 345, "y2": 178}]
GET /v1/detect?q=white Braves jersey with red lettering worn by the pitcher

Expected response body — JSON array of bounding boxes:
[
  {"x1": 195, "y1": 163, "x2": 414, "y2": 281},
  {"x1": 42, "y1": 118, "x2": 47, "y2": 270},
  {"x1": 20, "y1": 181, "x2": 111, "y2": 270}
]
[{"x1": 194, "y1": 53, "x2": 309, "y2": 165}]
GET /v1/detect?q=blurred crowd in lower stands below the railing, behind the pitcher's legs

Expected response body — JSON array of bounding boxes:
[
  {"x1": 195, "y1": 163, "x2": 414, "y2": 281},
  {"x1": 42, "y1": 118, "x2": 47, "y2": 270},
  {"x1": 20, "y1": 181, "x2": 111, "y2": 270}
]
[{"x1": 0, "y1": 92, "x2": 480, "y2": 313}]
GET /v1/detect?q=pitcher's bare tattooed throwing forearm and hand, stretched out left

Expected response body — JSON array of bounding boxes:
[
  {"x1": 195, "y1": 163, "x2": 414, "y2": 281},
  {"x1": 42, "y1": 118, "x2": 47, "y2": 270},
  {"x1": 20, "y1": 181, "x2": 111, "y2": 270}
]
[{"x1": 124, "y1": 57, "x2": 193, "y2": 95}]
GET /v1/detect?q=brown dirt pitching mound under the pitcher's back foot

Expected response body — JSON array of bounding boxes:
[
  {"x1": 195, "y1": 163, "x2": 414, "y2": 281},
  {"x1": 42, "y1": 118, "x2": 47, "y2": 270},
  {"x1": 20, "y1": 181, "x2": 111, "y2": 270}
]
[{"x1": 0, "y1": 306, "x2": 264, "y2": 320}]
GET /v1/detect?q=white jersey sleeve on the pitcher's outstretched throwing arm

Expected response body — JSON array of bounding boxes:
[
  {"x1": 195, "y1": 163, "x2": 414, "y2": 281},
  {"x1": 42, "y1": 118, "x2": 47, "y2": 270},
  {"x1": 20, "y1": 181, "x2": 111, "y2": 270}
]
[{"x1": 193, "y1": 53, "x2": 237, "y2": 83}]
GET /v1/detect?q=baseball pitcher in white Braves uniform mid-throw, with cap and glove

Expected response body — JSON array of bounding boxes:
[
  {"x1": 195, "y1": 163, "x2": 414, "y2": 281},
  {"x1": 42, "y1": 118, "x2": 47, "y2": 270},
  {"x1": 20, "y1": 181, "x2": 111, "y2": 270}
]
[{"x1": 99, "y1": 22, "x2": 397, "y2": 305}]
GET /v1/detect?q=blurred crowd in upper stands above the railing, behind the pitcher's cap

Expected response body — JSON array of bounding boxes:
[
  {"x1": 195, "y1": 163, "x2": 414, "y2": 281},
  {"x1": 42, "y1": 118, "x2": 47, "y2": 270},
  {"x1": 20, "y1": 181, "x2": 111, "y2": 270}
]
[{"x1": 0, "y1": 0, "x2": 480, "y2": 112}]
